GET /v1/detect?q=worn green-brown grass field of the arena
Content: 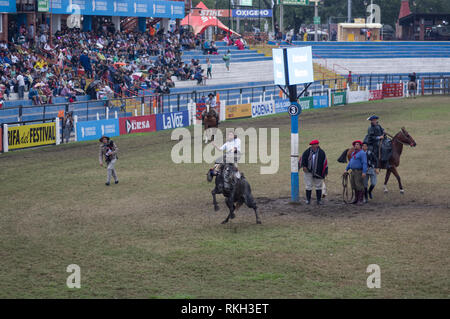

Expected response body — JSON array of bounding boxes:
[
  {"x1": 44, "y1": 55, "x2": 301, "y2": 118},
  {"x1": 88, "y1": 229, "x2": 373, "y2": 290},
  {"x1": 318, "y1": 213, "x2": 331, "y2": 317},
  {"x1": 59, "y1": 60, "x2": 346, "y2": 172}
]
[{"x1": 0, "y1": 97, "x2": 450, "y2": 298}]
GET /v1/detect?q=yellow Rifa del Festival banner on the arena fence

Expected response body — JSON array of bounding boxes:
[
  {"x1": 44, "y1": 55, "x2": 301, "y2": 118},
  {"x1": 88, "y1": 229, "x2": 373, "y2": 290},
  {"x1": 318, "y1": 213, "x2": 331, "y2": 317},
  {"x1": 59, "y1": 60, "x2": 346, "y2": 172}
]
[{"x1": 5, "y1": 122, "x2": 56, "y2": 150}]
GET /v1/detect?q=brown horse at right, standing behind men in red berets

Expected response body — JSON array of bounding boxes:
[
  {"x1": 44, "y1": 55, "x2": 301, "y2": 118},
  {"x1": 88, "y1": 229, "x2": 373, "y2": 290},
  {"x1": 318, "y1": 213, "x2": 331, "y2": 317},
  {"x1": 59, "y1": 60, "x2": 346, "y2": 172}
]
[{"x1": 338, "y1": 127, "x2": 417, "y2": 194}]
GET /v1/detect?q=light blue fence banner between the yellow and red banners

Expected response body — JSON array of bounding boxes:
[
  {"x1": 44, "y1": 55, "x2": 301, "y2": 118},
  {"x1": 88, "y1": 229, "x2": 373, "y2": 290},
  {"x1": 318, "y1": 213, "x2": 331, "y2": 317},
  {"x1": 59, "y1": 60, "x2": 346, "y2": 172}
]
[{"x1": 77, "y1": 119, "x2": 120, "y2": 141}]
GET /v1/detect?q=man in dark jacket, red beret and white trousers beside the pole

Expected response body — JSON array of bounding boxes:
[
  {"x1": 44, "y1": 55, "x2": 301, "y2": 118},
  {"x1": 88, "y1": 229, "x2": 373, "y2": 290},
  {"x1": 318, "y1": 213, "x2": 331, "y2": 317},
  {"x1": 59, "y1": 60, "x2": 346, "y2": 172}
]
[{"x1": 299, "y1": 140, "x2": 328, "y2": 205}]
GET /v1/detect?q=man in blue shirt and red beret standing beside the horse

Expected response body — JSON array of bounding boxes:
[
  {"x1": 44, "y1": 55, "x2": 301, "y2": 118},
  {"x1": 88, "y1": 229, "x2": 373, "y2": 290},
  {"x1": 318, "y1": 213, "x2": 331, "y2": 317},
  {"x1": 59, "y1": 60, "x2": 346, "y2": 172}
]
[{"x1": 345, "y1": 140, "x2": 367, "y2": 205}]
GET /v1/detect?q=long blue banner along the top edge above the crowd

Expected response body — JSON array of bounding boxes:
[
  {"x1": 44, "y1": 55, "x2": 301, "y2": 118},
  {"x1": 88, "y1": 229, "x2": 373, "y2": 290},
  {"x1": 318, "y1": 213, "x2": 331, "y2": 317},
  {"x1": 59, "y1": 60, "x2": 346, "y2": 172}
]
[{"x1": 51, "y1": 0, "x2": 184, "y2": 19}]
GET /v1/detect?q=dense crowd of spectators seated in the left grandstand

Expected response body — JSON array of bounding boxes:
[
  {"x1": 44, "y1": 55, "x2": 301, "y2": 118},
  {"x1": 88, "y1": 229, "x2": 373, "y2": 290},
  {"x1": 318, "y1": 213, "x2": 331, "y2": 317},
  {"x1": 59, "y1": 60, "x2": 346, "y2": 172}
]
[{"x1": 0, "y1": 24, "x2": 209, "y2": 105}]
